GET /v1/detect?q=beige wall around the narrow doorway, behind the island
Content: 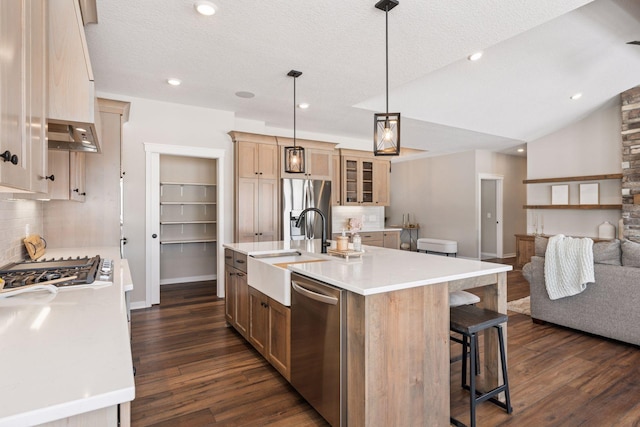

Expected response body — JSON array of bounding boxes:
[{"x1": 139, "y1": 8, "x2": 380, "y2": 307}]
[{"x1": 386, "y1": 151, "x2": 526, "y2": 258}]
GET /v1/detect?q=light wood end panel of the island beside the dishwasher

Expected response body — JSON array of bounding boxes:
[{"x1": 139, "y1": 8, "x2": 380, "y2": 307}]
[{"x1": 347, "y1": 282, "x2": 449, "y2": 426}]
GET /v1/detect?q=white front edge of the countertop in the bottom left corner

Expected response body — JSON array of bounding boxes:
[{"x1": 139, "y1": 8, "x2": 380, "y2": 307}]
[{"x1": 0, "y1": 384, "x2": 135, "y2": 427}]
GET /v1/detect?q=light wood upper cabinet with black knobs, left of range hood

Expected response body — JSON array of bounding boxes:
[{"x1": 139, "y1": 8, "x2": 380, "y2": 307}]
[{"x1": 0, "y1": 0, "x2": 47, "y2": 192}]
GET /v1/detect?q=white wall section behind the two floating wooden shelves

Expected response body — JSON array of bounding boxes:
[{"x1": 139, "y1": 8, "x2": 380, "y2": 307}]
[{"x1": 527, "y1": 97, "x2": 622, "y2": 237}]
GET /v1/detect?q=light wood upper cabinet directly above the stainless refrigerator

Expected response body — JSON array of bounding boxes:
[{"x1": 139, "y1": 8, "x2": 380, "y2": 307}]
[{"x1": 276, "y1": 136, "x2": 337, "y2": 181}]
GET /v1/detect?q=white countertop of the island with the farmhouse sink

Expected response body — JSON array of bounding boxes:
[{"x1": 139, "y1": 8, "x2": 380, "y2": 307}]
[{"x1": 224, "y1": 240, "x2": 512, "y2": 295}]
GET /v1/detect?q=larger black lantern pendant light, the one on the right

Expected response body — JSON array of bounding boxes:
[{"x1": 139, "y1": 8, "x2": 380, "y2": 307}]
[{"x1": 373, "y1": 0, "x2": 400, "y2": 156}]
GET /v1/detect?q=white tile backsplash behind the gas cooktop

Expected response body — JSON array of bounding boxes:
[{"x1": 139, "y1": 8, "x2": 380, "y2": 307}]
[{"x1": 0, "y1": 200, "x2": 43, "y2": 266}]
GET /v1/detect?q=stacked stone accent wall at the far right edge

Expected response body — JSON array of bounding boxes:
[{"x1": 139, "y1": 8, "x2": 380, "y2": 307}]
[{"x1": 620, "y1": 86, "x2": 640, "y2": 242}]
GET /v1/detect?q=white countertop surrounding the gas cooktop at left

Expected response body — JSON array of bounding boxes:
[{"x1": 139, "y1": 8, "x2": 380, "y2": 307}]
[{"x1": 0, "y1": 247, "x2": 135, "y2": 427}]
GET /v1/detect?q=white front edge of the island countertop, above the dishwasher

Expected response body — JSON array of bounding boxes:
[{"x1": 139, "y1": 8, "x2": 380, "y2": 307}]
[{"x1": 288, "y1": 264, "x2": 512, "y2": 296}]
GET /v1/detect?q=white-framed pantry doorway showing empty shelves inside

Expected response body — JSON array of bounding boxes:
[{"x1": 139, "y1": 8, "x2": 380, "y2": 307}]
[{"x1": 145, "y1": 144, "x2": 224, "y2": 306}]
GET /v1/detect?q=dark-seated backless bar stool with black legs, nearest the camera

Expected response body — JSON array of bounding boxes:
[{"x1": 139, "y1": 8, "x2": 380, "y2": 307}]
[{"x1": 450, "y1": 305, "x2": 513, "y2": 427}]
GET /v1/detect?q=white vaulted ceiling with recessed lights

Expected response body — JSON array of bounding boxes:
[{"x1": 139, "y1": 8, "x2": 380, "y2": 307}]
[{"x1": 86, "y1": 0, "x2": 640, "y2": 153}]
